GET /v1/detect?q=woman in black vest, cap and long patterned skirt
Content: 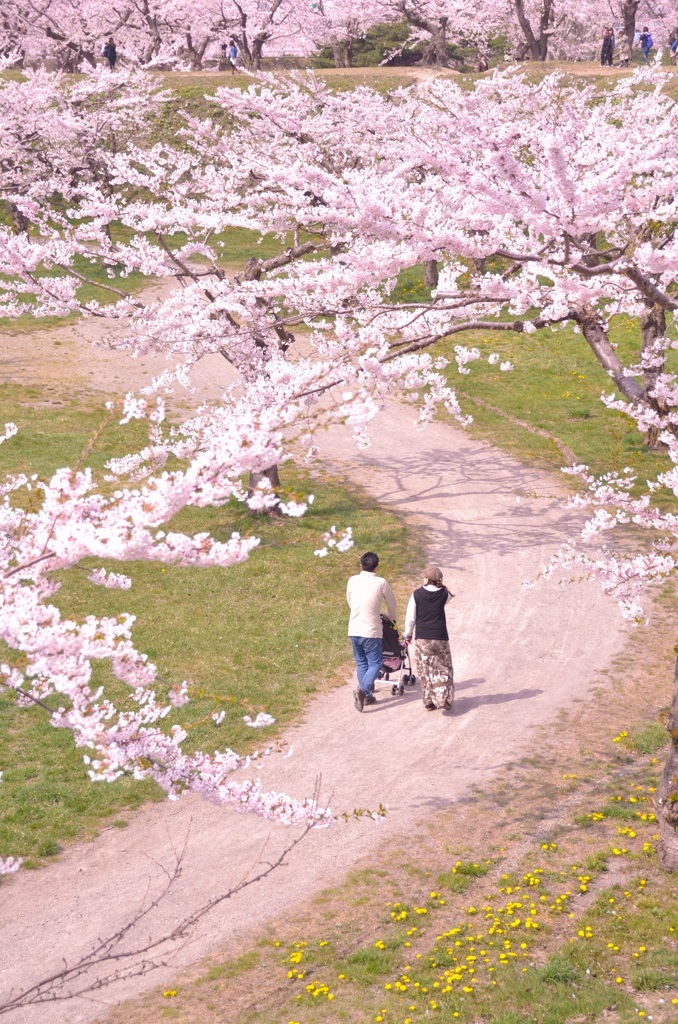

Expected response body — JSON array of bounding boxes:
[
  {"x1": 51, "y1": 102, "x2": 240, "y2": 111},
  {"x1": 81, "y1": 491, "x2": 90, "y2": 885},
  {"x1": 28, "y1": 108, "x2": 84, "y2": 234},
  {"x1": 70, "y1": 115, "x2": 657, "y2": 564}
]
[{"x1": 405, "y1": 565, "x2": 455, "y2": 711}]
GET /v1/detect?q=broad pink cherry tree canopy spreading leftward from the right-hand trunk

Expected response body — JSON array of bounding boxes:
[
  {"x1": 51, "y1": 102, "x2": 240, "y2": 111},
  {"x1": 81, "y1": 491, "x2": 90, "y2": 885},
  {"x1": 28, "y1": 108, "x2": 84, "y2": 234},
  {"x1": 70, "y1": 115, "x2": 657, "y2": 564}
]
[{"x1": 3, "y1": 64, "x2": 677, "y2": 448}]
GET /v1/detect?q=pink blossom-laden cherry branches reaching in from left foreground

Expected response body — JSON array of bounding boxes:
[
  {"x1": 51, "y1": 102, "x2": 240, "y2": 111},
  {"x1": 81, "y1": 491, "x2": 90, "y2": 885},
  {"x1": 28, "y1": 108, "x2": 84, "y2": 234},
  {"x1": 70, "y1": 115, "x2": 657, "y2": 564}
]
[{"x1": 0, "y1": 375, "x2": 350, "y2": 872}]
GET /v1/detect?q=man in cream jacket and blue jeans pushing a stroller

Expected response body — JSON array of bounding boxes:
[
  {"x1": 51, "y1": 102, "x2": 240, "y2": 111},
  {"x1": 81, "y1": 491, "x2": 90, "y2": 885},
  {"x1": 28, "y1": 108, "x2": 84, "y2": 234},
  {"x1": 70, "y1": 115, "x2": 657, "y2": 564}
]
[{"x1": 346, "y1": 551, "x2": 396, "y2": 711}]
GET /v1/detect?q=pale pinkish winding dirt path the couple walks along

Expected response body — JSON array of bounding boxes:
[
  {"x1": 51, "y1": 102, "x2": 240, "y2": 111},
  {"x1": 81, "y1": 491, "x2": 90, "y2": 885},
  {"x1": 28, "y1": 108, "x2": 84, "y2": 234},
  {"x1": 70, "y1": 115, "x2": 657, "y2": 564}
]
[{"x1": 0, "y1": 321, "x2": 623, "y2": 1024}]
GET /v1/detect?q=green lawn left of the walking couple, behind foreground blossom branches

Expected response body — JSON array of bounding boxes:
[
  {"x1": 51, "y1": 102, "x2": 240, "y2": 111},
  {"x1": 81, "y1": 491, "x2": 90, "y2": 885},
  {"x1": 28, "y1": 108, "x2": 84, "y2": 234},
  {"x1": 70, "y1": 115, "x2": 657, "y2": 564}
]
[{"x1": 0, "y1": 387, "x2": 417, "y2": 862}]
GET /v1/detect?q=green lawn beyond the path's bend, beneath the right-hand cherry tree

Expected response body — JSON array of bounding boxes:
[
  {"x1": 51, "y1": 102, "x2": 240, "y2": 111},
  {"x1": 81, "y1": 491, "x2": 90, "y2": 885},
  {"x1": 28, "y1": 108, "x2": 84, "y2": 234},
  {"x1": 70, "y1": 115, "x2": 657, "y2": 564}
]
[{"x1": 393, "y1": 267, "x2": 678, "y2": 479}]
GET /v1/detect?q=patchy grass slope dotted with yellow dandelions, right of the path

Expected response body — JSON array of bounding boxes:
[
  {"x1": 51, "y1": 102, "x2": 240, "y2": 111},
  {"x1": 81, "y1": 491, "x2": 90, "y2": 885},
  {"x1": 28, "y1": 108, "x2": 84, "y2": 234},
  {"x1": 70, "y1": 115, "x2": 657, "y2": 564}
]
[{"x1": 107, "y1": 593, "x2": 678, "y2": 1024}]
